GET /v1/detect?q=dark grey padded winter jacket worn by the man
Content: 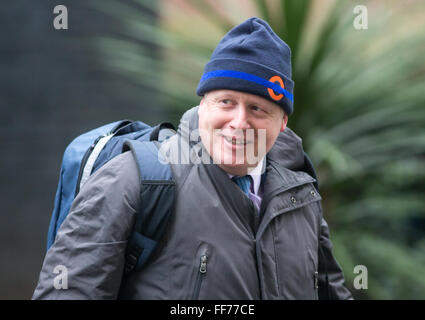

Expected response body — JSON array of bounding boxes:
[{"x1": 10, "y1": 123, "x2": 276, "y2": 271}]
[{"x1": 33, "y1": 108, "x2": 351, "y2": 299}]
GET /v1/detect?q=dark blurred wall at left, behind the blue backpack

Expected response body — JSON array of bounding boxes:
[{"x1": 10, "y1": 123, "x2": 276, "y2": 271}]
[{"x1": 0, "y1": 0, "x2": 164, "y2": 299}]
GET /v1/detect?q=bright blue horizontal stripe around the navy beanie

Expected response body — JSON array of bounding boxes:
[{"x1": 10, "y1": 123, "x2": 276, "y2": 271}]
[{"x1": 200, "y1": 70, "x2": 294, "y2": 102}]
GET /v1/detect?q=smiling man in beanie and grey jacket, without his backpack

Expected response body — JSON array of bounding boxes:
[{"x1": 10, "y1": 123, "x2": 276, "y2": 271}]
[{"x1": 33, "y1": 18, "x2": 351, "y2": 299}]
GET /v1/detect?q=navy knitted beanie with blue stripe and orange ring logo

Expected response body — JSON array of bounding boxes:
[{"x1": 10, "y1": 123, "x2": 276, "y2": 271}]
[{"x1": 196, "y1": 17, "x2": 294, "y2": 115}]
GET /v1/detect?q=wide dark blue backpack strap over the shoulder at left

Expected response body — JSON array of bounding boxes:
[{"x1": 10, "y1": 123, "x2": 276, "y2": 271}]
[{"x1": 123, "y1": 140, "x2": 175, "y2": 275}]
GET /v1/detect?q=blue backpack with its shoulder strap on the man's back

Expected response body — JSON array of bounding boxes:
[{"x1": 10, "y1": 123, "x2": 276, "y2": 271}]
[{"x1": 47, "y1": 120, "x2": 175, "y2": 274}]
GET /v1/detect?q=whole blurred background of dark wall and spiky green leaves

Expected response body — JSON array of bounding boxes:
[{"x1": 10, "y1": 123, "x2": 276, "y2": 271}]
[{"x1": 0, "y1": 0, "x2": 425, "y2": 299}]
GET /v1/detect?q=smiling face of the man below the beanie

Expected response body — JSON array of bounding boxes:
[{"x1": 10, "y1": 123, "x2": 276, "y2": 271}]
[{"x1": 198, "y1": 90, "x2": 288, "y2": 175}]
